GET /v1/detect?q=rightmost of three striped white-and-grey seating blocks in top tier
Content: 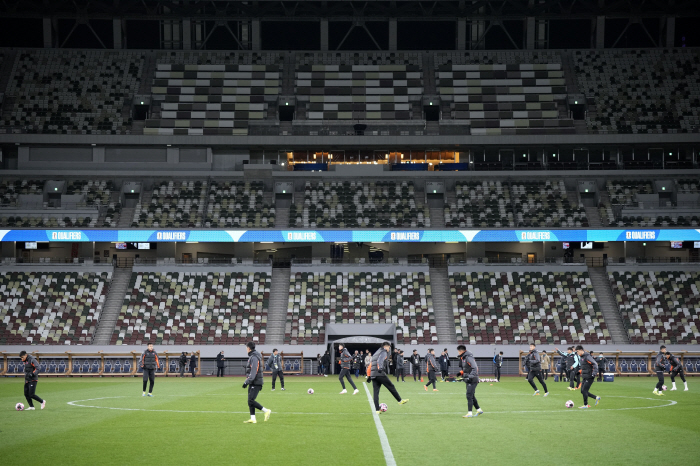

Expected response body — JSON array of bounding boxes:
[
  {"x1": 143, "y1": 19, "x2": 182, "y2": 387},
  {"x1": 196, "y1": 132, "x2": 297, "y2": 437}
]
[{"x1": 435, "y1": 52, "x2": 574, "y2": 134}]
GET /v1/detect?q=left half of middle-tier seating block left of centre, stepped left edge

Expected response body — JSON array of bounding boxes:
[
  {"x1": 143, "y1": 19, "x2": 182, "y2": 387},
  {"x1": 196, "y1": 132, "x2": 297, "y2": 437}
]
[{"x1": 131, "y1": 180, "x2": 208, "y2": 228}]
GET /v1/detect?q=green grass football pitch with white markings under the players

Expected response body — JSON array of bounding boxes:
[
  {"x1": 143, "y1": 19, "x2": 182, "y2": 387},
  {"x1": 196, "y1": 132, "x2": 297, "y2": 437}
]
[{"x1": 0, "y1": 376, "x2": 700, "y2": 466}]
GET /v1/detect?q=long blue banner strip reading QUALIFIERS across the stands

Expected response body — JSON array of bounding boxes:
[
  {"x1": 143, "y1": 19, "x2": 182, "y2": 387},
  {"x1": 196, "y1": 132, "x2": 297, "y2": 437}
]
[{"x1": 0, "y1": 229, "x2": 700, "y2": 243}]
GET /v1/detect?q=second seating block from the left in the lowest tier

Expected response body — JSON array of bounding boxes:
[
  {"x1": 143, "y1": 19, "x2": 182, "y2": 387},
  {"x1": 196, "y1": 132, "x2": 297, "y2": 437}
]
[{"x1": 111, "y1": 272, "x2": 270, "y2": 345}]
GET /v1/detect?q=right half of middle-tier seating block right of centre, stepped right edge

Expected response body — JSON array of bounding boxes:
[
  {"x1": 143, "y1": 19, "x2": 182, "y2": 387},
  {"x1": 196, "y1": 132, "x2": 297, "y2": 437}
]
[{"x1": 511, "y1": 180, "x2": 588, "y2": 228}]
